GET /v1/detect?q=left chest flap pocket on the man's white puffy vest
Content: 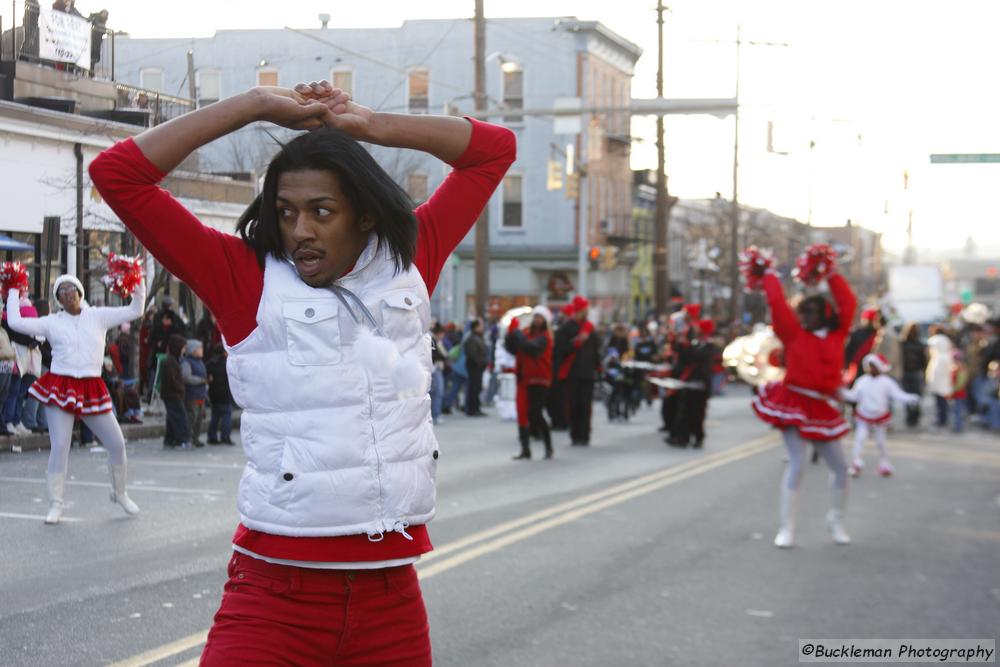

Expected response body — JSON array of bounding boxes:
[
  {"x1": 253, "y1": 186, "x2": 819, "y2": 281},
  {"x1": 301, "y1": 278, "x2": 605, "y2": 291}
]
[{"x1": 281, "y1": 301, "x2": 342, "y2": 366}]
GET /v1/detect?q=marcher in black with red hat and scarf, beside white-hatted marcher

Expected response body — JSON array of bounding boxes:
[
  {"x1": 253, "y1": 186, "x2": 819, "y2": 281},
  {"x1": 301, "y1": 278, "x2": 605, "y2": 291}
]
[{"x1": 559, "y1": 296, "x2": 601, "y2": 447}]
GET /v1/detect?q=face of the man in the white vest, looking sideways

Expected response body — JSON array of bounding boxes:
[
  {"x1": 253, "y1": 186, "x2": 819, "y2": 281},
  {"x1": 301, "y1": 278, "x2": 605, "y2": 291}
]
[{"x1": 275, "y1": 169, "x2": 375, "y2": 287}]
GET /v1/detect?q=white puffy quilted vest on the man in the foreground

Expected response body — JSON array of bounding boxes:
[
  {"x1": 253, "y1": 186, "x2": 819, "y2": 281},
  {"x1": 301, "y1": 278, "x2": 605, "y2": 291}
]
[{"x1": 227, "y1": 235, "x2": 438, "y2": 537}]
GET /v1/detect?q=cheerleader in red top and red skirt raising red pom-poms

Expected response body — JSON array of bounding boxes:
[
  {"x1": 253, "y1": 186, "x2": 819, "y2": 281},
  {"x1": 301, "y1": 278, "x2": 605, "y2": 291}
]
[{"x1": 744, "y1": 246, "x2": 857, "y2": 548}]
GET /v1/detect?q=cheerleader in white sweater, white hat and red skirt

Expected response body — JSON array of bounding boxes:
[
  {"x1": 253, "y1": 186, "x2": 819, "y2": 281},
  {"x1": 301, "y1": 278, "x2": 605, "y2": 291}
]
[{"x1": 7, "y1": 275, "x2": 146, "y2": 524}]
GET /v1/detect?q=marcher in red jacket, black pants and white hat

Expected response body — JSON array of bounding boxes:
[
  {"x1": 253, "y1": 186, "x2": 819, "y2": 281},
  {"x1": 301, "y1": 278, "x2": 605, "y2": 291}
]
[{"x1": 504, "y1": 306, "x2": 554, "y2": 460}]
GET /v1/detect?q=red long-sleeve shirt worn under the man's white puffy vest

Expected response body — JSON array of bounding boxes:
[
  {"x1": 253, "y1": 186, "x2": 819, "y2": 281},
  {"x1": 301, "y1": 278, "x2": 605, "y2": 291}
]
[{"x1": 90, "y1": 119, "x2": 516, "y2": 563}]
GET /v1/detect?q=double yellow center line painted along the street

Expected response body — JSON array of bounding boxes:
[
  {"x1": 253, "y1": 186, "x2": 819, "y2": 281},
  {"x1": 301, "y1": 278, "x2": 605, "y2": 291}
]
[{"x1": 111, "y1": 434, "x2": 778, "y2": 667}]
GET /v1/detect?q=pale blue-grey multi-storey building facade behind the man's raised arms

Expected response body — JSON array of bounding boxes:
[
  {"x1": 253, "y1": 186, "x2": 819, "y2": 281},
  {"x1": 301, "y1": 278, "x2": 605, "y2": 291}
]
[{"x1": 109, "y1": 18, "x2": 641, "y2": 320}]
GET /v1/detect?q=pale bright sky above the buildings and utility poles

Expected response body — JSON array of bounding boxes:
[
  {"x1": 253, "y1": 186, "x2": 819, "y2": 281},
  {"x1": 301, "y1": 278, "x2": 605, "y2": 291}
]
[{"x1": 0, "y1": 0, "x2": 1000, "y2": 258}]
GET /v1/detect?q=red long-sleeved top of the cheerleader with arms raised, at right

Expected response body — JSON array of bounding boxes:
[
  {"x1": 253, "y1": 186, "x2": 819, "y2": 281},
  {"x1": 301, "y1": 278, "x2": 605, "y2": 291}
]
[{"x1": 764, "y1": 273, "x2": 858, "y2": 394}]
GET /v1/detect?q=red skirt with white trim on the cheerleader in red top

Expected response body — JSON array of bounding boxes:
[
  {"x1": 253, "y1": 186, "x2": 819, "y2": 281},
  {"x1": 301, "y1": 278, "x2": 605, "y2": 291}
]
[{"x1": 753, "y1": 382, "x2": 850, "y2": 442}]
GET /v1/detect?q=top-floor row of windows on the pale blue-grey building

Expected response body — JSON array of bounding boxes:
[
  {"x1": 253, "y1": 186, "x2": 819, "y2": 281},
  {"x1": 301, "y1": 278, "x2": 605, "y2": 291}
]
[{"x1": 139, "y1": 67, "x2": 524, "y2": 117}]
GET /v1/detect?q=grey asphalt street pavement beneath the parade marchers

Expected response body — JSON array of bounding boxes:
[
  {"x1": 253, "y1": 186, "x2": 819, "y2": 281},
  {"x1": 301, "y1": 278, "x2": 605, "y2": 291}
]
[{"x1": 0, "y1": 394, "x2": 1000, "y2": 667}]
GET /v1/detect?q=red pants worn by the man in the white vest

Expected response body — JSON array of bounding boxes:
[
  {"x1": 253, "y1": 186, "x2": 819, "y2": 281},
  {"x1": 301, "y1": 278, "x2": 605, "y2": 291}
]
[{"x1": 201, "y1": 553, "x2": 431, "y2": 667}]
